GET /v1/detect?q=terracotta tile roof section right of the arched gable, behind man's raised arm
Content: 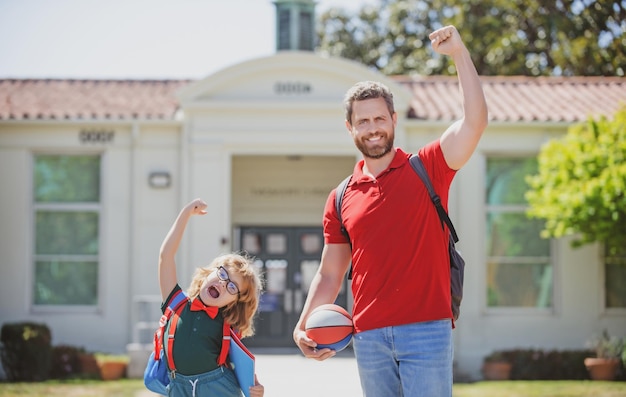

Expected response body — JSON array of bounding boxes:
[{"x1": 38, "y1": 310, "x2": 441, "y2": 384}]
[{"x1": 394, "y1": 76, "x2": 626, "y2": 122}]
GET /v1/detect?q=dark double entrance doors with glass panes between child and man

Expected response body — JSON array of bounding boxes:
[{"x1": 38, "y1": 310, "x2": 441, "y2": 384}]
[{"x1": 239, "y1": 227, "x2": 347, "y2": 347}]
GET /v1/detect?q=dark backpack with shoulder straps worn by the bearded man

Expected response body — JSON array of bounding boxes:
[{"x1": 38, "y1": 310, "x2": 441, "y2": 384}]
[{"x1": 335, "y1": 155, "x2": 465, "y2": 321}]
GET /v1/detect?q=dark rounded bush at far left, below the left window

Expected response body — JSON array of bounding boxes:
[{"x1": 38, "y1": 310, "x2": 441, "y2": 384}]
[{"x1": 0, "y1": 322, "x2": 52, "y2": 382}]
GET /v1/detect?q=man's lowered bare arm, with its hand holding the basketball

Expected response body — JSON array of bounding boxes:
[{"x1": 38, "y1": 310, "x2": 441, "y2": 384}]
[{"x1": 293, "y1": 244, "x2": 352, "y2": 360}]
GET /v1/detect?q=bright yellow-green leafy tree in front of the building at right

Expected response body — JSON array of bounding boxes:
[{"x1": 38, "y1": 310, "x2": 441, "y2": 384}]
[{"x1": 526, "y1": 105, "x2": 626, "y2": 254}]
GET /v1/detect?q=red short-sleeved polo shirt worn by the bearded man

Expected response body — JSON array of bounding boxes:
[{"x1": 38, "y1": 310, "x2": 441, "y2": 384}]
[{"x1": 324, "y1": 140, "x2": 456, "y2": 332}]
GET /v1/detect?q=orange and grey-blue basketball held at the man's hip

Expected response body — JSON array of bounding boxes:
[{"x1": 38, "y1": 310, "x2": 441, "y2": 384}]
[{"x1": 305, "y1": 303, "x2": 354, "y2": 351}]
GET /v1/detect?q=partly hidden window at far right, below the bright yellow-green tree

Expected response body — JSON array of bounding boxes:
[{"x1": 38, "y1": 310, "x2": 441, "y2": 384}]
[{"x1": 604, "y1": 246, "x2": 626, "y2": 309}]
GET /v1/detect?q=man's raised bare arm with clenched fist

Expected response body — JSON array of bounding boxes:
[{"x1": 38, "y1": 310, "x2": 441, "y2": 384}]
[{"x1": 429, "y1": 26, "x2": 487, "y2": 170}]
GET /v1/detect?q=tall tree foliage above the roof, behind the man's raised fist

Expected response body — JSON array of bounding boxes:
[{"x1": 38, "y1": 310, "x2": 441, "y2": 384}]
[{"x1": 318, "y1": 0, "x2": 626, "y2": 76}]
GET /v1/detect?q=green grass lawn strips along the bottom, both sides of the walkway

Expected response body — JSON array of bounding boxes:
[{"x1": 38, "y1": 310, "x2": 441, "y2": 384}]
[{"x1": 0, "y1": 379, "x2": 626, "y2": 397}]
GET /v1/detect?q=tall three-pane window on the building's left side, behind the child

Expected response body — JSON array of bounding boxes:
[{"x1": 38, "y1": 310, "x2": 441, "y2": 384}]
[{"x1": 33, "y1": 155, "x2": 100, "y2": 305}]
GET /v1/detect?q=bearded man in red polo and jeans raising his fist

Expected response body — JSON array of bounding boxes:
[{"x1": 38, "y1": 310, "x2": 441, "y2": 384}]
[{"x1": 294, "y1": 26, "x2": 487, "y2": 397}]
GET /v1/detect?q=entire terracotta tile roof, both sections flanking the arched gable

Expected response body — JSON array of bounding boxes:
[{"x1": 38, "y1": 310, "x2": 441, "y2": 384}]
[{"x1": 0, "y1": 76, "x2": 626, "y2": 122}]
